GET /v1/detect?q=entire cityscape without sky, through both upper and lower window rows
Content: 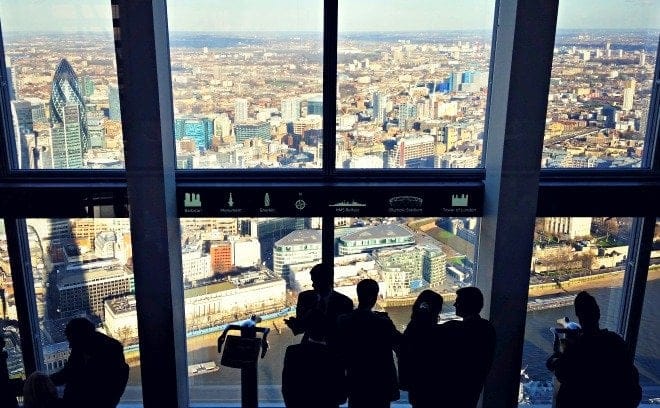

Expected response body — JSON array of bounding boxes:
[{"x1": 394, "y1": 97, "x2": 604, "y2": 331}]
[{"x1": 0, "y1": 3, "x2": 660, "y2": 405}]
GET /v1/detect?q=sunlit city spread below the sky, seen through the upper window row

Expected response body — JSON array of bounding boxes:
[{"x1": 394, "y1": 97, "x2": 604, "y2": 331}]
[{"x1": 5, "y1": 30, "x2": 656, "y2": 169}]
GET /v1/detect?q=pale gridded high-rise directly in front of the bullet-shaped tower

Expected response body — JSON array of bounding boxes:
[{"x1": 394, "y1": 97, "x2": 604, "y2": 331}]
[{"x1": 51, "y1": 104, "x2": 84, "y2": 169}]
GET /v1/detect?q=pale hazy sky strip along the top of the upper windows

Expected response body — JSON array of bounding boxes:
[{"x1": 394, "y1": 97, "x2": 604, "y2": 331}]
[{"x1": 0, "y1": 0, "x2": 660, "y2": 31}]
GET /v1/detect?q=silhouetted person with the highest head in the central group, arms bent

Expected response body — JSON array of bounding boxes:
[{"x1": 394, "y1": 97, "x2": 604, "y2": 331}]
[{"x1": 284, "y1": 264, "x2": 353, "y2": 345}]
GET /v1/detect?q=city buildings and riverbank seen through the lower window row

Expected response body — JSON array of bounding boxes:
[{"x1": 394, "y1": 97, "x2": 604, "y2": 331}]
[{"x1": 0, "y1": 217, "x2": 660, "y2": 401}]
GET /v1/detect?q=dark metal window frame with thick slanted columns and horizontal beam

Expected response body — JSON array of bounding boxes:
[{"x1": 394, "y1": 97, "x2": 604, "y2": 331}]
[{"x1": 0, "y1": 0, "x2": 660, "y2": 407}]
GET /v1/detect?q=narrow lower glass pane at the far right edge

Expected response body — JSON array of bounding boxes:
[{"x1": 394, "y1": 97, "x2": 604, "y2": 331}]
[{"x1": 635, "y1": 219, "x2": 660, "y2": 403}]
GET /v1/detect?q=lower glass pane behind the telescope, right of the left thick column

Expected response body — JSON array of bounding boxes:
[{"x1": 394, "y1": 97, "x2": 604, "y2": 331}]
[{"x1": 180, "y1": 218, "x2": 321, "y2": 403}]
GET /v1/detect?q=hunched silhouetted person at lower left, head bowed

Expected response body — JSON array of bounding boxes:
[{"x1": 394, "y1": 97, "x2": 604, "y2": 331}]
[{"x1": 50, "y1": 318, "x2": 129, "y2": 408}]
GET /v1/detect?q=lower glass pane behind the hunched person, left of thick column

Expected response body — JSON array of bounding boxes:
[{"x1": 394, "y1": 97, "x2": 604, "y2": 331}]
[{"x1": 26, "y1": 218, "x2": 142, "y2": 403}]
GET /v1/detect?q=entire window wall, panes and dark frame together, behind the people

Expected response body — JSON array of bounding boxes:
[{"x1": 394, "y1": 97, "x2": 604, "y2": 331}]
[{"x1": 0, "y1": 0, "x2": 660, "y2": 408}]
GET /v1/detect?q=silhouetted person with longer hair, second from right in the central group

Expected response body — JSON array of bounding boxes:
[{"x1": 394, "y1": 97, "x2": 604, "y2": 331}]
[{"x1": 399, "y1": 289, "x2": 446, "y2": 408}]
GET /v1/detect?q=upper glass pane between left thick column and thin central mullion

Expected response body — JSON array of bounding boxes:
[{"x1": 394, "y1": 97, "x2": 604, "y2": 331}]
[{"x1": 168, "y1": 0, "x2": 323, "y2": 169}]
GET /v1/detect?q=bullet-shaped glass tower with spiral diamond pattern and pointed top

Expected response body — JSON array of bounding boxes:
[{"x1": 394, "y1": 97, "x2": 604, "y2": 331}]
[{"x1": 50, "y1": 59, "x2": 89, "y2": 155}]
